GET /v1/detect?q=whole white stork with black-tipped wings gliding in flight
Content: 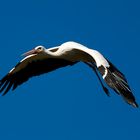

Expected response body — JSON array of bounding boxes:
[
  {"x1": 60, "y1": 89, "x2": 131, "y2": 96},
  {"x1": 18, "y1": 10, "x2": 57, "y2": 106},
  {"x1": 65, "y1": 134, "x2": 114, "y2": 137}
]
[{"x1": 0, "y1": 41, "x2": 138, "y2": 107}]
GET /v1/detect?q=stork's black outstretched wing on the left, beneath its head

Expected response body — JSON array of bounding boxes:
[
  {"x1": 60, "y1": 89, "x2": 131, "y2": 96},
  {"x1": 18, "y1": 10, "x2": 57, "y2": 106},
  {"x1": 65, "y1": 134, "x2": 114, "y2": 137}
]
[{"x1": 0, "y1": 55, "x2": 77, "y2": 95}]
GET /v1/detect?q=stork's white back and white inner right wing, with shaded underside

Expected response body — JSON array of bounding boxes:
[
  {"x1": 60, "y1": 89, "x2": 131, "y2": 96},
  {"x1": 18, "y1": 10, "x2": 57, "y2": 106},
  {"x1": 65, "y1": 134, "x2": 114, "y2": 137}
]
[{"x1": 59, "y1": 42, "x2": 109, "y2": 67}]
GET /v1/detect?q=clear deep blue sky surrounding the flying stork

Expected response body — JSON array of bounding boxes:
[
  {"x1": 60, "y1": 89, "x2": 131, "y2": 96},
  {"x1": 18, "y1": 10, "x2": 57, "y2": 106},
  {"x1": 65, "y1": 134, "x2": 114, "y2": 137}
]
[{"x1": 0, "y1": 0, "x2": 140, "y2": 140}]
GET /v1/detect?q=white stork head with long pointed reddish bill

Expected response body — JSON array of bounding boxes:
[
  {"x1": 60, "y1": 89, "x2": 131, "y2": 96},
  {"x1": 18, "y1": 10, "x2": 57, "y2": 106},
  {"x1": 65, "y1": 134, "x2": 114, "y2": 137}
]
[{"x1": 23, "y1": 46, "x2": 45, "y2": 56}]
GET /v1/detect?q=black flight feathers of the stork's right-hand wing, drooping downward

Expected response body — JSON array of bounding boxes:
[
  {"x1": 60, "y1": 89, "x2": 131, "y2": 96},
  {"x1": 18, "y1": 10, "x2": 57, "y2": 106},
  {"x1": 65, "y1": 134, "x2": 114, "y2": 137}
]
[{"x1": 99, "y1": 61, "x2": 138, "y2": 107}]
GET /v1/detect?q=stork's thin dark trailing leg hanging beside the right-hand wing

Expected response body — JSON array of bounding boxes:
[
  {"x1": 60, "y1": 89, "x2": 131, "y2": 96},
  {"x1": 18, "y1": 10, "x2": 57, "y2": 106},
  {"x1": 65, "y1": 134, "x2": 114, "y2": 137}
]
[{"x1": 85, "y1": 62, "x2": 110, "y2": 96}]
